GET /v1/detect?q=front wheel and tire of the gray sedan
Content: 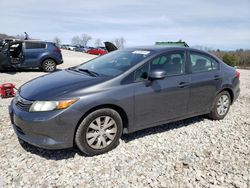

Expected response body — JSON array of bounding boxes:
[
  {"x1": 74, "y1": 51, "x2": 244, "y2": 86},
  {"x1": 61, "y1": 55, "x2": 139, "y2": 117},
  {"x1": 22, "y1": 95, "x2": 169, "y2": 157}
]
[{"x1": 75, "y1": 108, "x2": 123, "y2": 156}]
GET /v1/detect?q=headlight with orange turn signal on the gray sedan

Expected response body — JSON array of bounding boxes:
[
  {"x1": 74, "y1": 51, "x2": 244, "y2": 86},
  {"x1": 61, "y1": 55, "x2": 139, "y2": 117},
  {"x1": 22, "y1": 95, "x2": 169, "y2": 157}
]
[{"x1": 29, "y1": 99, "x2": 78, "y2": 112}]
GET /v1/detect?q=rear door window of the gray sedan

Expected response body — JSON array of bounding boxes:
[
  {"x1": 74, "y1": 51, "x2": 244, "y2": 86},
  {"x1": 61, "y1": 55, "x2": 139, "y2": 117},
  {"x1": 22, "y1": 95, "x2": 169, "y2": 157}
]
[{"x1": 190, "y1": 52, "x2": 219, "y2": 73}]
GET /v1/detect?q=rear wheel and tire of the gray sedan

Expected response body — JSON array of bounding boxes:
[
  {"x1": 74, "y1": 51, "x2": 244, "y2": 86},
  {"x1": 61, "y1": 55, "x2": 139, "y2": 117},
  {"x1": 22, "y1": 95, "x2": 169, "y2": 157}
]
[{"x1": 208, "y1": 91, "x2": 231, "y2": 120}]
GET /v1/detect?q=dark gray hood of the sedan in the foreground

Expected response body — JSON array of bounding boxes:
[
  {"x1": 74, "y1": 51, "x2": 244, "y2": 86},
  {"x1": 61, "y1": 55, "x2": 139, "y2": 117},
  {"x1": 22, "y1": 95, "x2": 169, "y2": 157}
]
[{"x1": 19, "y1": 70, "x2": 108, "y2": 100}]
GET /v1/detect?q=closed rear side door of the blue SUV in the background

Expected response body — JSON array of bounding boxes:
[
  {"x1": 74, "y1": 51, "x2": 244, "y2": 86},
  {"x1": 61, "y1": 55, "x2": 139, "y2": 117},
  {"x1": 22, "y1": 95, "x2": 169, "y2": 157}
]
[{"x1": 22, "y1": 41, "x2": 46, "y2": 67}]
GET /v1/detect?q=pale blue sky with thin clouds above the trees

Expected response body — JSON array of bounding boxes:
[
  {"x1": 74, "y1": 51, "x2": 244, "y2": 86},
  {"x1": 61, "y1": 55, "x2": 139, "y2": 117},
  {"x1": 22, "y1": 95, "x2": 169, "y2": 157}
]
[{"x1": 0, "y1": 0, "x2": 250, "y2": 50}]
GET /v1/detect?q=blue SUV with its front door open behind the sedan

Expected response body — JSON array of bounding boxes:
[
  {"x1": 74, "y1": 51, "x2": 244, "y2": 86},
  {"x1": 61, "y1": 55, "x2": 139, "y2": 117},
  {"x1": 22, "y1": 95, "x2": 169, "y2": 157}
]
[{"x1": 0, "y1": 40, "x2": 63, "y2": 72}]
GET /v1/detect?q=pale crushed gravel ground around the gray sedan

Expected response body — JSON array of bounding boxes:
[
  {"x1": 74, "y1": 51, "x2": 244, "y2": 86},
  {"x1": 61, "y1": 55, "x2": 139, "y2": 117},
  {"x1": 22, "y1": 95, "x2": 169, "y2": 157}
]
[{"x1": 0, "y1": 51, "x2": 250, "y2": 188}]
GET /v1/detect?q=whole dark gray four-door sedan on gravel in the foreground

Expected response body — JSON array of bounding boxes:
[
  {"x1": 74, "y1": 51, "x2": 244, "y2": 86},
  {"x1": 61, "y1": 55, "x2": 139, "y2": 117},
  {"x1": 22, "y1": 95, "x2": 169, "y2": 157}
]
[{"x1": 9, "y1": 46, "x2": 240, "y2": 155}]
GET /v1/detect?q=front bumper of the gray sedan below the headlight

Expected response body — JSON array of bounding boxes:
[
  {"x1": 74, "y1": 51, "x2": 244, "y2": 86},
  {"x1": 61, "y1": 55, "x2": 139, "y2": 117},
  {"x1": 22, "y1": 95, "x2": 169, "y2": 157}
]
[{"x1": 9, "y1": 102, "x2": 80, "y2": 149}]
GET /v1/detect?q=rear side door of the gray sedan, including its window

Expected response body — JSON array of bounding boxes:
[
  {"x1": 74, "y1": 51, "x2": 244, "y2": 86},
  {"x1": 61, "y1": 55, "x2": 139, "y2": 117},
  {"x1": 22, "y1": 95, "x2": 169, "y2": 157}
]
[{"x1": 188, "y1": 51, "x2": 222, "y2": 114}]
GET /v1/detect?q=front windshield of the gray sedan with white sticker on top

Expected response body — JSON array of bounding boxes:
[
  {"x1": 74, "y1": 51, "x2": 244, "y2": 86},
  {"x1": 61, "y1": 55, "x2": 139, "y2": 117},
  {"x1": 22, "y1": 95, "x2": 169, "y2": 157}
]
[{"x1": 77, "y1": 50, "x2": 151, "y2": 77}]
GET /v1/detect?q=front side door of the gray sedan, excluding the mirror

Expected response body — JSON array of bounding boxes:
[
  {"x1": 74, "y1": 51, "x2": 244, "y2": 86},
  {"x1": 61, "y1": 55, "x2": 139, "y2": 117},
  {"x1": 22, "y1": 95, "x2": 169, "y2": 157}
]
[{"x1": 134, "y1": 51, "x2": 190, "y2": 129}]
